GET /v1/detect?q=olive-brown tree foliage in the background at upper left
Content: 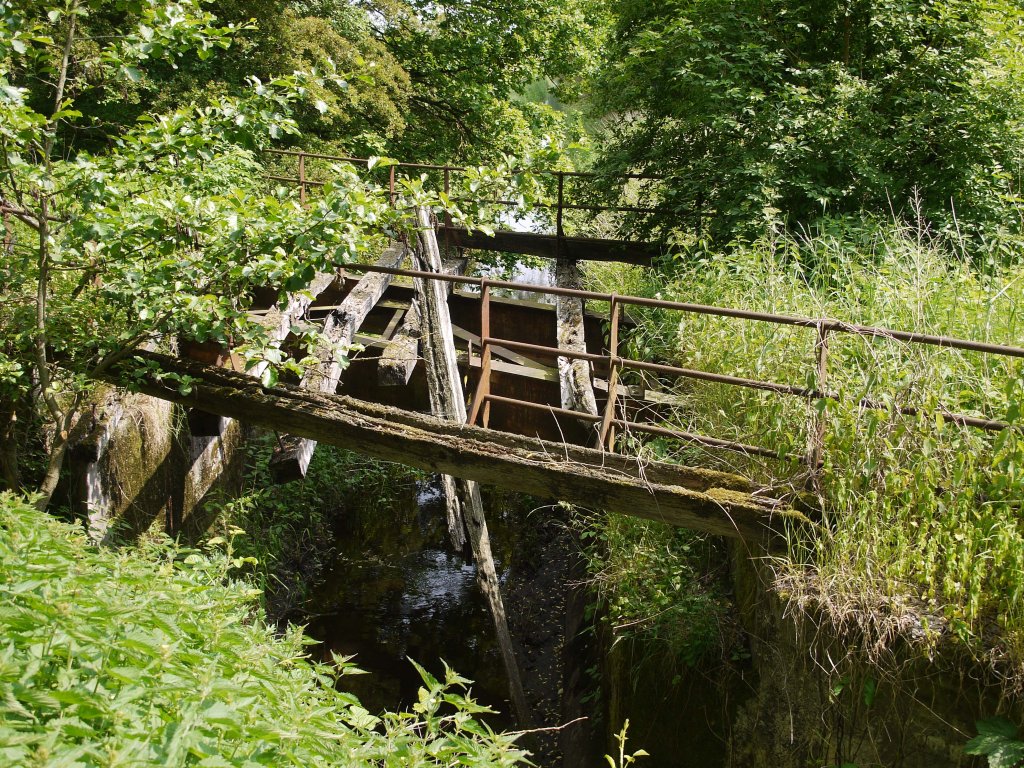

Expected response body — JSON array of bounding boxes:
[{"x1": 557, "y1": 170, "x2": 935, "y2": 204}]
[{"x1": 12, "y1": 0, "x2": 409, "y2": 156}]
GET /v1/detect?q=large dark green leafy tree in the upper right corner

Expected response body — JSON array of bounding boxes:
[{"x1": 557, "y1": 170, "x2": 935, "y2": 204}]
[{"x1": 596, "y1": 0, "x2": 1024, "y2": 253}]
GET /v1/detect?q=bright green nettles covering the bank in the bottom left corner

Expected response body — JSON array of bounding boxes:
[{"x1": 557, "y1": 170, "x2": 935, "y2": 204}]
[{"x1": 0, "y1": 495, "x2": 522, "y2": 768}]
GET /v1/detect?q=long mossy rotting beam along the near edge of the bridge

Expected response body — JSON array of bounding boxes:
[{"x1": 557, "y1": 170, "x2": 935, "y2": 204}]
[{"x1": 108, "y1": 352, "x2": 797, "y2": 542}]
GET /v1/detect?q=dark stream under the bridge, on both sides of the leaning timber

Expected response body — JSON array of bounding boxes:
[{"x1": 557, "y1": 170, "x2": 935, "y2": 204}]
[{"x1": 303, "y1": 479, "x2": 604, "y2": 766}]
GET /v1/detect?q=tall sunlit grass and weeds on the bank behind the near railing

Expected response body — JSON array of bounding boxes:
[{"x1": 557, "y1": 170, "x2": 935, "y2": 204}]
[{"x1": 589, "y1": 215, "x2": 1024, "y2": 666}]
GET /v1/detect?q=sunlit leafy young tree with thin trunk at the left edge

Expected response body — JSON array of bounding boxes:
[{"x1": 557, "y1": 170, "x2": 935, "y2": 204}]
[{"x1": 0, "y1": 0, "x2": 544, "y2": 507}]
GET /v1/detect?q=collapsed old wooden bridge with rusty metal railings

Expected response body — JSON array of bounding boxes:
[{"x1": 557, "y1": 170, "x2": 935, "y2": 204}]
[{"x1": 99, "y1": 153, "x2": 1024, "y2": 541}]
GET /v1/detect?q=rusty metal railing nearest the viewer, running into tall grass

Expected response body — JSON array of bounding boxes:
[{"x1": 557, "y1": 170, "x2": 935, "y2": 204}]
[{"x1": 348, "y1": 264, "x2": 1024, "y2": 469}]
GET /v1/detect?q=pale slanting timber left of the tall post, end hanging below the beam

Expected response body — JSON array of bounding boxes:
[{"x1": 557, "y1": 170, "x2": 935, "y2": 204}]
[{"x1": 269, "y1": 245, "x2": 406, "y2": 482}]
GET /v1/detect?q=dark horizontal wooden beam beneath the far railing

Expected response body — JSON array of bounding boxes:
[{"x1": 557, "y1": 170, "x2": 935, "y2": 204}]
[{"x1": 438, "y1": 226, "x2": 662, "y2": 266}]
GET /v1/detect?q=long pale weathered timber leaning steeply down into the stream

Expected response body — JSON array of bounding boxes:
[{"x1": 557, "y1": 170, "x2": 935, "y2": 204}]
[{"x1": 415, "y1": 208, "x2": 532, "y2": 728}]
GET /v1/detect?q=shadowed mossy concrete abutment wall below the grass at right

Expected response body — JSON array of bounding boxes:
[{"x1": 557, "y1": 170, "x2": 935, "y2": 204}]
[{"x1": 602, "y1": 546, "x2": 1024, "y2": 768}]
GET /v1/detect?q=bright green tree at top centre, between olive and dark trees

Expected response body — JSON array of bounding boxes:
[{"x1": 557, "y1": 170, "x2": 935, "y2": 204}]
[{"x1": 365, "y1": 0, "x2": 604, "y2": 162}]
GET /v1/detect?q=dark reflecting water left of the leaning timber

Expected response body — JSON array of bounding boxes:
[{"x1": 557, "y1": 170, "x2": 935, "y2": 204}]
[{"x1": 299, "y1": 482, "x2": 512, "y2": 728}]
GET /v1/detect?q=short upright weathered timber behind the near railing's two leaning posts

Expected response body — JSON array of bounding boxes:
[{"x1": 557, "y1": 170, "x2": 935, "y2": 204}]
[{"x1": 555, "y1": 258, "x2": 597, "y2": 439}]
